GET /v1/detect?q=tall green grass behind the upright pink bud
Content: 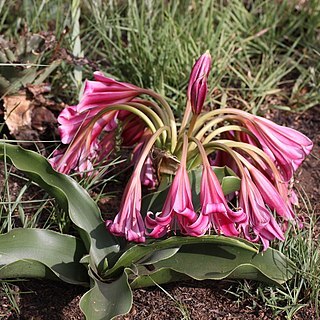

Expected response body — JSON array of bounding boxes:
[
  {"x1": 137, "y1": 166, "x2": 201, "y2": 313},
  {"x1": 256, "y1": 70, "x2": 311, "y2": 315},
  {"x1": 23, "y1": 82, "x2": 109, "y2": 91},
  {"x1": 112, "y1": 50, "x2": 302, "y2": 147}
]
[{"x1": 82, "y1": 0, "x2": 320, "y2": 115}]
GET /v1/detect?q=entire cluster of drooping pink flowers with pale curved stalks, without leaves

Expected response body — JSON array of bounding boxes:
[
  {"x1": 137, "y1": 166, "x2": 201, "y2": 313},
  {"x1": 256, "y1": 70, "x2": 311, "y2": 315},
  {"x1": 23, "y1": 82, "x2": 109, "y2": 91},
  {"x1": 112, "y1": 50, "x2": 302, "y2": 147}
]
[{"x1": 51, "y1": 52, "x2": 312, "y2": 249}]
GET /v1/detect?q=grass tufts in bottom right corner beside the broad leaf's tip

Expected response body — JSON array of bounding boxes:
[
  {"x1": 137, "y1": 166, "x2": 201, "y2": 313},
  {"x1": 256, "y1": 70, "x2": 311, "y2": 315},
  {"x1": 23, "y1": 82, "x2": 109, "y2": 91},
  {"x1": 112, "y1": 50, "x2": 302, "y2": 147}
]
[{"x1": 227, "y1": 196, "x2": 320, "y2": 319}]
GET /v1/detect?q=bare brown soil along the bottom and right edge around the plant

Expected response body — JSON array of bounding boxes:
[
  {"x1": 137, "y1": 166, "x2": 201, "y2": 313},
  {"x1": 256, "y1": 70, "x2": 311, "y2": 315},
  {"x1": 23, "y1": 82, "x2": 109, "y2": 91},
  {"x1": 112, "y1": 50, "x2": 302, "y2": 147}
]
[{"x1": 0, "y1": 107, "x2": 320, "y2": 320}]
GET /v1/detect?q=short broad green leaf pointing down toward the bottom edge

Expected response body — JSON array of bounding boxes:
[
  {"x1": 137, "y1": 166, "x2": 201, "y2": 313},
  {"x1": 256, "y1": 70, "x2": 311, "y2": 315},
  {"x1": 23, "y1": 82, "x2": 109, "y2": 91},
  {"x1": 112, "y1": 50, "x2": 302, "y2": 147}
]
[{"x1": 80, "y1": 270, "x2": 132, "y2": 320}]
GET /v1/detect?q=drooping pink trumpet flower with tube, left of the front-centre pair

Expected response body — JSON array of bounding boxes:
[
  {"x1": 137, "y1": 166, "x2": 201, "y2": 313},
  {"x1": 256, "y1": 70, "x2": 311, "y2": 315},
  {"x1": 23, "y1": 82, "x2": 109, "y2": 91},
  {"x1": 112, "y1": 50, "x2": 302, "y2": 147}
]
[{"x1": 145, "y1": 137, "x2": 199, "y2": 238}]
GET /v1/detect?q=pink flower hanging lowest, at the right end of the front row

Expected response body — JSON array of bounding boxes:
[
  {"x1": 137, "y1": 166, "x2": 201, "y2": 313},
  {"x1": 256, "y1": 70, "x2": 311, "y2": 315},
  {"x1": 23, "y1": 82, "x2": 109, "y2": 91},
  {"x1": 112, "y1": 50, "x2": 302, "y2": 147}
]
[{"x1": 239, "y1": 169, "x2": 284, "y2": 250}]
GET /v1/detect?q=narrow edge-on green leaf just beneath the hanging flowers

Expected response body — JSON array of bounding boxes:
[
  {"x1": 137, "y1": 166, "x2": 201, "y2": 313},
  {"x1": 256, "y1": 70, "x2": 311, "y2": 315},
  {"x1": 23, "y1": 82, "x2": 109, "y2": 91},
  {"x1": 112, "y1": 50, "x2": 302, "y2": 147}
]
[{"x1": 103, "y1": 235, "x2": 258, "y2": 277}]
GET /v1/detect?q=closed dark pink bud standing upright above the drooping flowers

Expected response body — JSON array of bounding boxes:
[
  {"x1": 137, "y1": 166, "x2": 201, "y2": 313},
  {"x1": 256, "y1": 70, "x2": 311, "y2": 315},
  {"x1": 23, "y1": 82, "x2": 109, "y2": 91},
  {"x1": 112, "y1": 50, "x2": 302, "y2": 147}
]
[{"x1": 187, "y1": 52, "x2": 211, "y2": 114}]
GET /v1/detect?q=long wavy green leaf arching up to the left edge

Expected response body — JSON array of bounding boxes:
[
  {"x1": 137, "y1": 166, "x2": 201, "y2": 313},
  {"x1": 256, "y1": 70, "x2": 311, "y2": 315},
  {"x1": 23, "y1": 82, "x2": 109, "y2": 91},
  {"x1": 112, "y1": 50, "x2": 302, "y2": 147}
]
[{"x1": 0, "y1": 142, "x2": 119, "y2": 268}]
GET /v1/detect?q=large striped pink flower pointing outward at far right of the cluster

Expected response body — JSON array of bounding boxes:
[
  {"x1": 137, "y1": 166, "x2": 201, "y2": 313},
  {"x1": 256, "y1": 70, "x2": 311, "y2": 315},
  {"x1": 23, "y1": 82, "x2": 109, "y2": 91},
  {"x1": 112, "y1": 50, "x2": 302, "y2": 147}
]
[{"x1": 243, "y1": 114, "x2": 313, "y2": 181}]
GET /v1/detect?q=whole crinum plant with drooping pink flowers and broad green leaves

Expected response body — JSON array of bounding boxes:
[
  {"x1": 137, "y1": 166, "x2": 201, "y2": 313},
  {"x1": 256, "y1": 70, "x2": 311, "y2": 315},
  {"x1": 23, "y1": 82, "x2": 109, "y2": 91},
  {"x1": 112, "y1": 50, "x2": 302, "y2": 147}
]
[{"x1": 0, "y1": 52, "x2": 312, "y2": 320}]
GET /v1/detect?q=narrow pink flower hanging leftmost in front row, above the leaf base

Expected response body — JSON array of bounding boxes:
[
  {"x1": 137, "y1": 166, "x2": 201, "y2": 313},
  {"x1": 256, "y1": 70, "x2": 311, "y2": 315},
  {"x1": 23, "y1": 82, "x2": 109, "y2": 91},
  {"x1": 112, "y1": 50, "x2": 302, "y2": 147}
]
[{"x1": 106, "y1": 171, "x2": 145, "y2": 242}]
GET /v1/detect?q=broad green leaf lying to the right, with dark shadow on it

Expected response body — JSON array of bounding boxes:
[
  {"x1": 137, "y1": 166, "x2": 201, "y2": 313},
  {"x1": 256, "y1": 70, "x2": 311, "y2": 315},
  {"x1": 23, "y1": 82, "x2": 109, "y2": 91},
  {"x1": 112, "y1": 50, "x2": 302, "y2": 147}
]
[{"x1": 131, "y1": 243, "x2": 294, "y2": 288}]
